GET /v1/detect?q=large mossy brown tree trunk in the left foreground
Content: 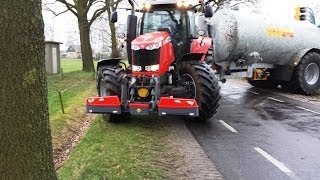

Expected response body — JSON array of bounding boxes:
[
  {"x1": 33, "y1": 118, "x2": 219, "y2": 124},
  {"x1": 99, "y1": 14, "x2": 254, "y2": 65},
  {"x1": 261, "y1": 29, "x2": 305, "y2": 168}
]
[{"x1": 0, "y1": 0, "x2": 56, "y2": 179}]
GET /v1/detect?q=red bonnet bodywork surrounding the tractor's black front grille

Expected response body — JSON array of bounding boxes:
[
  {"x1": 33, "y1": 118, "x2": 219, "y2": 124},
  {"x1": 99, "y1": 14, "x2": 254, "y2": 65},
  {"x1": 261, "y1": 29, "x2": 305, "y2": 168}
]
[{"x1": 131, "y1": 31, "x2": 175, "y2": 76}]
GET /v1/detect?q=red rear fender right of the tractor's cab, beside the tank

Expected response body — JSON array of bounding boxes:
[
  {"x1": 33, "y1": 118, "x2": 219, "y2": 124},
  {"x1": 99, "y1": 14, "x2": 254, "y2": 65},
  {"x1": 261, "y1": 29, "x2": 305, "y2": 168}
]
[{"x1": 191, "y1": 37, "x2": 212, "y2": 61}]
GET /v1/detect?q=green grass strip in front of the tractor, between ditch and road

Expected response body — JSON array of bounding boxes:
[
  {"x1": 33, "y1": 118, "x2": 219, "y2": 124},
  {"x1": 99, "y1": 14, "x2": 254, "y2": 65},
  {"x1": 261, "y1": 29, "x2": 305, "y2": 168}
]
[{"x1": 58, "y1": 116, "x2": 176, "y2": 179}]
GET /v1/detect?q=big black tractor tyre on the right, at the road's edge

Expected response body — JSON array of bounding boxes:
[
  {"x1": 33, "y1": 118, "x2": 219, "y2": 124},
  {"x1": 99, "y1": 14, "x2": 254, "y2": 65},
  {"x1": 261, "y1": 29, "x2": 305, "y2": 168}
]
[{"x1": 178, "y1": 61, "x2": 221, "y2": 121}]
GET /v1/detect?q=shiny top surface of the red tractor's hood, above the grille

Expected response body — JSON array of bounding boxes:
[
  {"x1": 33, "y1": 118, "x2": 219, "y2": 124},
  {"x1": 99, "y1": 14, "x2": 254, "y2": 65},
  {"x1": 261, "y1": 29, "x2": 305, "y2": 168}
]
[{"x1": 131, "y1": 31, "x2": 171, "y2": 51}]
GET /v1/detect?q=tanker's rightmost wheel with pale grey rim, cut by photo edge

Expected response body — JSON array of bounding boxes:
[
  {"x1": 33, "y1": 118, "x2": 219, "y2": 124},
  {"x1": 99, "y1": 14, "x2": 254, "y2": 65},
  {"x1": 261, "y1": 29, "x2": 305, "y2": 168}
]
[{"x1": 287, "y1": 52, "x2": 320, "y2": 95}]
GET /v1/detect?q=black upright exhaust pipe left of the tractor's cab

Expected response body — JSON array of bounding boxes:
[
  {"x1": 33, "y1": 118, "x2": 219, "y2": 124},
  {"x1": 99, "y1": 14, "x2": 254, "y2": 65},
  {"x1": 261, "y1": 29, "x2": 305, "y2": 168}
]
[{"x1": 127, "y1": 0, "x2": 138, "y2": 65}]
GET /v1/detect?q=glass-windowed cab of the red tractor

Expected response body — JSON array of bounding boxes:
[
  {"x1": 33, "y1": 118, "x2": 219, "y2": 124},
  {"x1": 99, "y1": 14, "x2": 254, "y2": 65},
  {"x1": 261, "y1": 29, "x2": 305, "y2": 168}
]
[{"x1": 140, "y1": 3, "x2": 195, "y2": 58}]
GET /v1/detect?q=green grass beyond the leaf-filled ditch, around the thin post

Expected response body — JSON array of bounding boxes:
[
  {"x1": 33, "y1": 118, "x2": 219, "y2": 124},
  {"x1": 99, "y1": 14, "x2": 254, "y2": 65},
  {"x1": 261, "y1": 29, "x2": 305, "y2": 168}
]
[{"x1": 48, "y1": 60, "x2": 96, "y2": 149}]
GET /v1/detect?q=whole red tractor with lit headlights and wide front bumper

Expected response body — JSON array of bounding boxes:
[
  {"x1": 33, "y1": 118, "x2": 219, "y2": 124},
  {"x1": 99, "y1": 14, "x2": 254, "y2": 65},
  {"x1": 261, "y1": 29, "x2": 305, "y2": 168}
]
[{"x1": 87, "y1": 0, "x2": 220, "y2": 122}]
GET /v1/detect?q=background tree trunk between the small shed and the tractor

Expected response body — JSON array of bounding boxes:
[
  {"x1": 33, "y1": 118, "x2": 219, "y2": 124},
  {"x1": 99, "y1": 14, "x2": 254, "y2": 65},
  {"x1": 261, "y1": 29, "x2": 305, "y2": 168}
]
[{"x1": 78, "y1": 17, "x2": 95, "y2": 72}]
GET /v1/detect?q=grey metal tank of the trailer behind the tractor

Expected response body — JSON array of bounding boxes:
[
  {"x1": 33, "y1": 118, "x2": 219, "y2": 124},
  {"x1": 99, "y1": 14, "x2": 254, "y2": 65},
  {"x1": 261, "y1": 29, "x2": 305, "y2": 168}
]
[{"x1": 210, "y1": 9, "x2": 320, "y2": 66}]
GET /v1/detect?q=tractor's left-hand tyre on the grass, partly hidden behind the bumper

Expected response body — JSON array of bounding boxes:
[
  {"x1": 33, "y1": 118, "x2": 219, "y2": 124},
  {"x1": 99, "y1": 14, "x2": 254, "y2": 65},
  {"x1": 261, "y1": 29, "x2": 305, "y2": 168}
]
[{"x1": 97, "y1": 66, "x2": 129, "y2": 123}]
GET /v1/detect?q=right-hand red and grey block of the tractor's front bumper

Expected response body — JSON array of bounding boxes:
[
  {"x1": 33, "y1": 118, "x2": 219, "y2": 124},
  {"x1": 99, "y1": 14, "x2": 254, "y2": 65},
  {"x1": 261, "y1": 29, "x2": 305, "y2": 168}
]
[{"x1": 158, "y1": 97, "x2": 199, "y2": 117}]
